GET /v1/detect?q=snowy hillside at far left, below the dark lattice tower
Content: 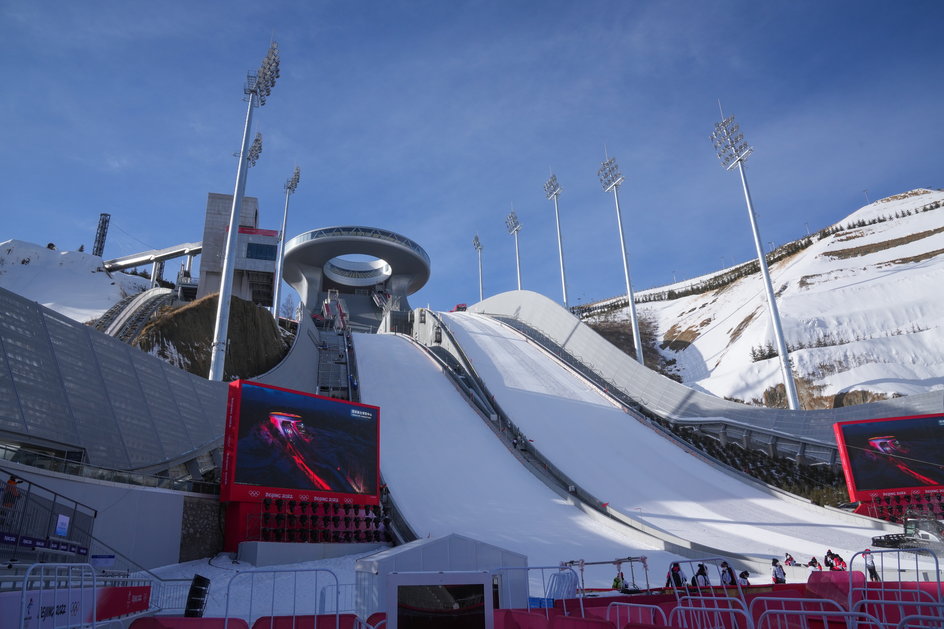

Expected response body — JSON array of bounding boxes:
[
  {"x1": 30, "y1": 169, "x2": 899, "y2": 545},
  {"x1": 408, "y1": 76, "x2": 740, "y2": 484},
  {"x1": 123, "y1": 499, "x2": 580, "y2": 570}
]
[{"x1": 0, "y1": 240, "x2": 151, "y2": 323}]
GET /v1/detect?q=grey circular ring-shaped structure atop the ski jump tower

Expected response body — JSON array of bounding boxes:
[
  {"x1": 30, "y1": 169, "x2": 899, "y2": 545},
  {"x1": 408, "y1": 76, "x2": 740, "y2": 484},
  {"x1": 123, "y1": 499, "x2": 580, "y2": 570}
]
[{"x1": 283, "y1": 226, "x2": 430, "y2": 318}]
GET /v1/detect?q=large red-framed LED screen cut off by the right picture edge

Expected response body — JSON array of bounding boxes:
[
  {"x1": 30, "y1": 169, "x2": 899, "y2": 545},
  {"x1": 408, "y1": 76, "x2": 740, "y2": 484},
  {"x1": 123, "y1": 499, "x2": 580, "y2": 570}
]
[{"x1": 833, "y1": 415, "x2": 944, "y2": 500}]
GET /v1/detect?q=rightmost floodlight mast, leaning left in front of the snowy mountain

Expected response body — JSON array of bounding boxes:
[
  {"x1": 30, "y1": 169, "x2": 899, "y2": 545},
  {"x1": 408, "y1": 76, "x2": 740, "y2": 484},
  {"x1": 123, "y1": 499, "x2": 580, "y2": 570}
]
[{"x1": 711, "y1": 111, "x2": 800, "y2": 410}]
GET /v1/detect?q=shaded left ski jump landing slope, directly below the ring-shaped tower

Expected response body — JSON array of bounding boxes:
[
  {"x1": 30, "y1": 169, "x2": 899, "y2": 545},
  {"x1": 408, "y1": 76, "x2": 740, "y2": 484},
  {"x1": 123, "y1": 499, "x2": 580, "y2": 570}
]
[{"x1": 354, "y1": 334, "x2": 682, "y2": 587}]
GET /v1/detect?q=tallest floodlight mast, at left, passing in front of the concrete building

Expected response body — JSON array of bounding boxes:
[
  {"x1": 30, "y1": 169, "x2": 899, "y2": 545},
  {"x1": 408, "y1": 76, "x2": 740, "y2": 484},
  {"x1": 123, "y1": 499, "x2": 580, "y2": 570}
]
[{"x1": 208, "y1": 42, "x2": 279, "y2": 380}]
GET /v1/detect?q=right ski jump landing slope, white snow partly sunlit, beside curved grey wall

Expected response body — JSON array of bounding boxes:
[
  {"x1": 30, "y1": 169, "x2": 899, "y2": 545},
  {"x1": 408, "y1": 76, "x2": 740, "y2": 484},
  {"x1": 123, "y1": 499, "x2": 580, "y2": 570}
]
[{"x1": 443, "y1": 312, "x2": 884, "y2": 561}]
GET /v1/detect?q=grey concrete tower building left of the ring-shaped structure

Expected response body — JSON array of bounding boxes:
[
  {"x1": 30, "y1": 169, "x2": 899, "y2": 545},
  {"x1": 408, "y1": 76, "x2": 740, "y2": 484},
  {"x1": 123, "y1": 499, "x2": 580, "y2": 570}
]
[{"x1": 197, "y1": 192, "x2": 279, "y2": 307}]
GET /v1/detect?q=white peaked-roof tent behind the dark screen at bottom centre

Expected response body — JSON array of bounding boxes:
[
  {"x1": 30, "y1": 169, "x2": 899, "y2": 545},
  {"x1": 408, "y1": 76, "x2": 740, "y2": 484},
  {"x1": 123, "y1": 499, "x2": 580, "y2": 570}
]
[{"x1": 354, "y1": 534, "x2": 528, "y2": 618}]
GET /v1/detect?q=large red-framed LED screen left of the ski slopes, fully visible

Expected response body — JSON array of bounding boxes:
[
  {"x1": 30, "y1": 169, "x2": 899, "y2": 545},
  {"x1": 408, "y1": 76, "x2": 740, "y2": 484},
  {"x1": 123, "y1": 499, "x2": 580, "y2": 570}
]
[{"x1": 220, "y1": 380, "x2": 380, "y2": 504}]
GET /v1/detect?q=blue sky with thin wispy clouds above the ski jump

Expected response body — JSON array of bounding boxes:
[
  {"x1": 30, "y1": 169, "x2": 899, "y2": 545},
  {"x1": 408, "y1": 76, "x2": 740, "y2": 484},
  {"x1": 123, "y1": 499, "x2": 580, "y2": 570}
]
[{"x1": 0, "y1": 0, "x2": 944, "y2": 309}]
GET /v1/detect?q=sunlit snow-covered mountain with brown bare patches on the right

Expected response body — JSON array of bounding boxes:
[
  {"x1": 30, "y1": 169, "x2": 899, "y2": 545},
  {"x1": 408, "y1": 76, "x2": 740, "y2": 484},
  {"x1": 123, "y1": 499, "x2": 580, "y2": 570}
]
[{"x1": 594, "y1": 189, "x2": 944, "y2": 401}]
